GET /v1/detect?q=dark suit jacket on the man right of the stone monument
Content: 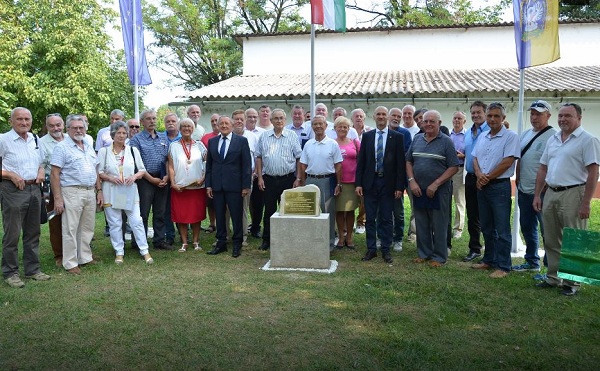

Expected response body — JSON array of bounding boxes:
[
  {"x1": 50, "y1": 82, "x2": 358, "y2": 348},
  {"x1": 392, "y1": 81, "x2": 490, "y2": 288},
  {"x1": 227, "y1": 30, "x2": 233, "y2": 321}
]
[{"x1": 355, "y1": 129, "x2": 406, "y2": 193}]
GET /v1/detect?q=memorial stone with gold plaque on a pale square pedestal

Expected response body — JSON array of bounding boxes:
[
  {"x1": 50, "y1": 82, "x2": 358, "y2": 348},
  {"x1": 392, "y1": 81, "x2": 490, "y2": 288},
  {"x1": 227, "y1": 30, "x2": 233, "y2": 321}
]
[{"x1": 270, "y1": 184, "x2": 332, "y2": 269}]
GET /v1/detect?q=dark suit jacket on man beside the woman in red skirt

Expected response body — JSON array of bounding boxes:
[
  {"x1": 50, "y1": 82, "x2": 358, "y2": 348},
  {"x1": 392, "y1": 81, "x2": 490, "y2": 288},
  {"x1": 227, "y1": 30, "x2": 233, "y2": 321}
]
[{"x1": 206, "y1": 134, "x2": 252, "y2": 192}]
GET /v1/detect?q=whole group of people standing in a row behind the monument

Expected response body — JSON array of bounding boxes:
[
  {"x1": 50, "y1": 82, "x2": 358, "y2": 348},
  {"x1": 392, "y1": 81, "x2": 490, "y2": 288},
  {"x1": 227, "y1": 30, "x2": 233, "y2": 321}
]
[{"x1": 0, "y1": 100, "x2": 600, "y2": 295}]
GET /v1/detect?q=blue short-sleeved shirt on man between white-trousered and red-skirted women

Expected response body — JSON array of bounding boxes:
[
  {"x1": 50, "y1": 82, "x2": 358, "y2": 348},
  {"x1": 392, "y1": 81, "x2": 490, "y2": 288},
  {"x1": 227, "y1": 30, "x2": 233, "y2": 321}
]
[{"x1": 129, "y1": 130, "x2": 169, "y2": 177}]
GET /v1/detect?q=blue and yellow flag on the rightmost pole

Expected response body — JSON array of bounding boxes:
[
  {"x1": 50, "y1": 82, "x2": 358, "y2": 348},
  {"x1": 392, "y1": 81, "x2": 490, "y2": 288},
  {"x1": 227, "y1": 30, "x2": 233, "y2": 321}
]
[{"x1": 513, "y1": 0, "x2": 560, "y2": 69}]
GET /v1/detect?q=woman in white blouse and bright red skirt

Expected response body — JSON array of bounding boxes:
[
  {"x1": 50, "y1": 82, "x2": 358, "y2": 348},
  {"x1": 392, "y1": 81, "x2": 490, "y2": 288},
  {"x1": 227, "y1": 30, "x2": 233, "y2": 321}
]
[{"x1": 168, "y1": 118, "x2": 206, "y2": 252}]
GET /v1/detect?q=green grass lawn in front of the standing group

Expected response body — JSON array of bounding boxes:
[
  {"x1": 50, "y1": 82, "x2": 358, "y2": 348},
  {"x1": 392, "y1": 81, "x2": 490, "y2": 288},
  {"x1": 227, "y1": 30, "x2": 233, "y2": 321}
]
[{"x1": 0, "y1": 201, "x2": 600, "y2": 370}]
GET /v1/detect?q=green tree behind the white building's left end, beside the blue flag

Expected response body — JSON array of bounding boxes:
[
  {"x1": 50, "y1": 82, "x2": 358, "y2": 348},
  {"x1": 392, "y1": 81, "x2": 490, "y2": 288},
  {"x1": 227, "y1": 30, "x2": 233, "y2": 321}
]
[{"x1": 144, "y1": 0, "x2": 308, "y2": 89}]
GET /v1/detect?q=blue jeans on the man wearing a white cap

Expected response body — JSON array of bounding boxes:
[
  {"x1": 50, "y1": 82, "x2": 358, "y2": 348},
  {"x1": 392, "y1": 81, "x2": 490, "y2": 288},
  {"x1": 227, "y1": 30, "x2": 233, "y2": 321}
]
[{"x1": 519, "y1": 191, "x2": 544, "y2": 268}]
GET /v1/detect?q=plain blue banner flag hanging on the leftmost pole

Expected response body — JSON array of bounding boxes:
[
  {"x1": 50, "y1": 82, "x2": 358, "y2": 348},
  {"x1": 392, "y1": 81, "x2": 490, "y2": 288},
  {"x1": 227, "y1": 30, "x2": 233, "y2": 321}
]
[{"x1": 119, "y1": 0, "x2": 152, "y2": 85}]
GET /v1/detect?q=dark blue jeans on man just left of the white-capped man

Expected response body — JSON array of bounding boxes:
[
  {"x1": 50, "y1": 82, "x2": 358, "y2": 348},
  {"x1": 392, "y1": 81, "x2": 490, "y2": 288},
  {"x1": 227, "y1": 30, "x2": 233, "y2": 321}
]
[{"x1": 477, "y1": 179, "x2": 512, "y2": 272}]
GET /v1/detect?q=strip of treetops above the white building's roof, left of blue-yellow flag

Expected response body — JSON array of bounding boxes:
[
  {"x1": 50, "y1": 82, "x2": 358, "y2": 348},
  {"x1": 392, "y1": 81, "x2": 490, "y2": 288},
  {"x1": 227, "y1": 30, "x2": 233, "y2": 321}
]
[{"x1": 346, "y1": 0, "x2": 512, "y2": 27}]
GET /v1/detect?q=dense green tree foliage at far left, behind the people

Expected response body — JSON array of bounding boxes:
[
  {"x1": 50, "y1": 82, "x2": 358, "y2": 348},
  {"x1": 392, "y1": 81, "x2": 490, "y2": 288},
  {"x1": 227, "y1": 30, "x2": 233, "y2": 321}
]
[{"x1": 0, "y1": 0, "x2": 133, "y2": 130}]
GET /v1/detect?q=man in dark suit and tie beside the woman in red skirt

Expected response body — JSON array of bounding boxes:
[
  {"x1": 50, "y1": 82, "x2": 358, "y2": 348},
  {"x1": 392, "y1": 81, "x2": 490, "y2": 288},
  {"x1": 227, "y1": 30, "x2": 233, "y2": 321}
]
[{"x1": 206, "y1": 116, "x2": 252, "y2": 258}]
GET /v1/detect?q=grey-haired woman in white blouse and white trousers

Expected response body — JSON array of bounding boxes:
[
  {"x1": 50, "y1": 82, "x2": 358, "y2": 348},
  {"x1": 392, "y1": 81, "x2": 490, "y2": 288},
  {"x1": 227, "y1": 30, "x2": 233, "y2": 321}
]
[{"x1": 98, "y1": 121, "x2": 154, "y2": 264}]
